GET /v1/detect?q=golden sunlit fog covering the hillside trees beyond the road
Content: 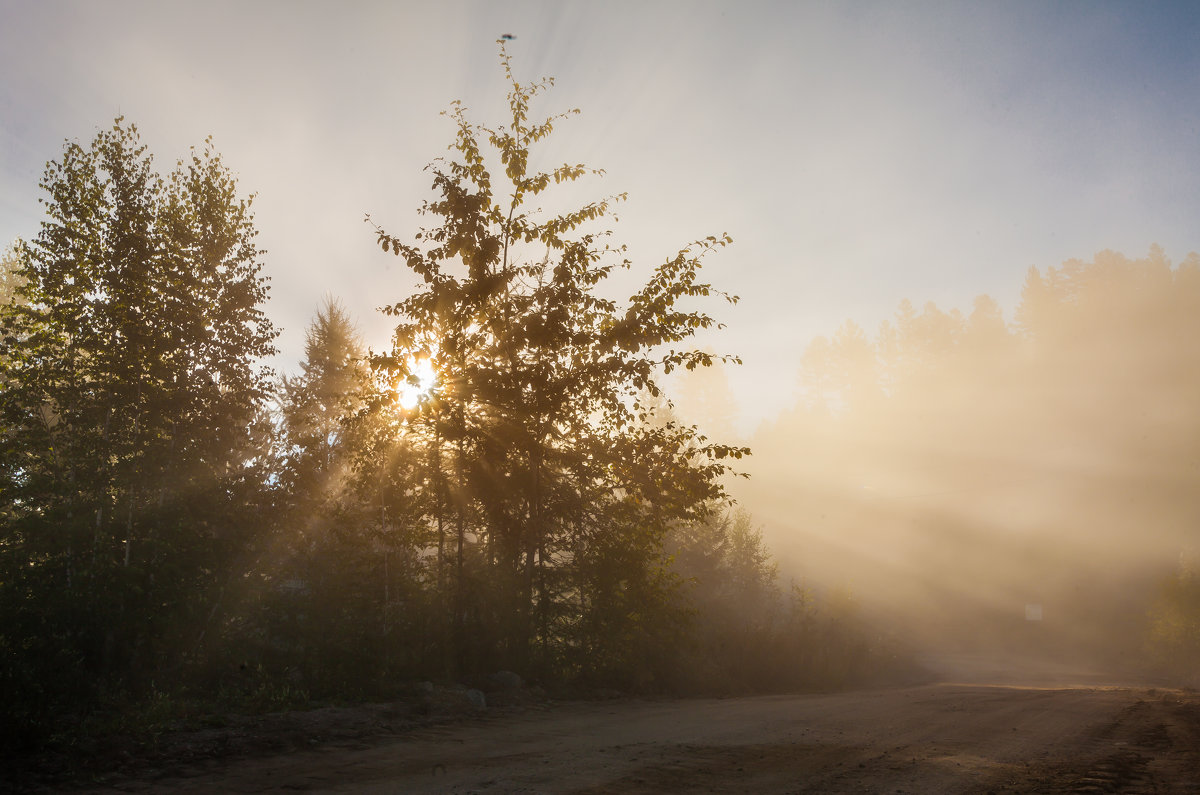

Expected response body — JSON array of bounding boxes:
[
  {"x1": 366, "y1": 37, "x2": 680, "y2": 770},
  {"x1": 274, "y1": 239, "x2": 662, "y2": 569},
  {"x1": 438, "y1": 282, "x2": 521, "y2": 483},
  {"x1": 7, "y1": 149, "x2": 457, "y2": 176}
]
[{"x1": 676, "y1": 247, "x2": 1200, "y2": 670}]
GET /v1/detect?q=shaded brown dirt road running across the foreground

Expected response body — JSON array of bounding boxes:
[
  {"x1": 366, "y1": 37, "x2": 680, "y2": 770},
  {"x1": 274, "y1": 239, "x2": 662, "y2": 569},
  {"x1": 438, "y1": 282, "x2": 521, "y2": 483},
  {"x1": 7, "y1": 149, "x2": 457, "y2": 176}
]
[{"x1": 88, "y1": 662, "x2": 1200, "y2": 794}]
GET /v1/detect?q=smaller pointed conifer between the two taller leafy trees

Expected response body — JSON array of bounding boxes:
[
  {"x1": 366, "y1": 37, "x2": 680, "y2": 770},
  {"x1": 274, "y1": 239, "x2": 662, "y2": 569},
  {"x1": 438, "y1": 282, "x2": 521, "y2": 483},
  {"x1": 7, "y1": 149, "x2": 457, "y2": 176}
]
[{"x1": 272, "y1": 299, "x2": 436, "y2": 694}]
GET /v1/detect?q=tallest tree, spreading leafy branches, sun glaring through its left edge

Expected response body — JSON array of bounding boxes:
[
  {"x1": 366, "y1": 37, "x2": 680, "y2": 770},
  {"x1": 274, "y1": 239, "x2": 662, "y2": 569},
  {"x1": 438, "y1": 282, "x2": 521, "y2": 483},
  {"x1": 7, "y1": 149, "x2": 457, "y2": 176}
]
[{"x1": 364, "y1": 41, "x2": 745, "y2": 682}]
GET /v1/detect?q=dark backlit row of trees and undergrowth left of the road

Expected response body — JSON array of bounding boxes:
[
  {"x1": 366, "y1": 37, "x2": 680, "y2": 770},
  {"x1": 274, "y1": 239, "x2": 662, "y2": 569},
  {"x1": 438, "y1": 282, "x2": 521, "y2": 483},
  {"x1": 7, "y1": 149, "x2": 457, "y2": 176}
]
[{"x1": 0, "y1": 43, "x2": 892, "y2": 747}]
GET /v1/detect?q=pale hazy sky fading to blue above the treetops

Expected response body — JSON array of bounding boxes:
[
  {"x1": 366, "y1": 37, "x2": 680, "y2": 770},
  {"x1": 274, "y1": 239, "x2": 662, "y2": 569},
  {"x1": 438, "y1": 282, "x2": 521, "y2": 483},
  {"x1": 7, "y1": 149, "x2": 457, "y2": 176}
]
[{"x1": 0, "y1": 0, "x2": 1200, "y2": 432}]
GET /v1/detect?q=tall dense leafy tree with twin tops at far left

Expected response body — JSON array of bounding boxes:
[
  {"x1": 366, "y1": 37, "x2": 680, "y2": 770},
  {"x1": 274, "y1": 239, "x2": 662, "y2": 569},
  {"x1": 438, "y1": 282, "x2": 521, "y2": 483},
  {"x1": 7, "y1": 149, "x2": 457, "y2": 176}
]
[{"x1": 0, "y1": 119, "x2": 275, "y2": 734}]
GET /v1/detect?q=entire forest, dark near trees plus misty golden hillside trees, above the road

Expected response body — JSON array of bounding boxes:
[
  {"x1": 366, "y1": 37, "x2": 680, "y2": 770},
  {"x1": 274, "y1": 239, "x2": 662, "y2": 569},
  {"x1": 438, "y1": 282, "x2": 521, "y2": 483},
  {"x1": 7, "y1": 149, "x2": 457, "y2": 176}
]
[{"x1": 0, "y1": 43, "x2": 1200, "y2": 768}]
